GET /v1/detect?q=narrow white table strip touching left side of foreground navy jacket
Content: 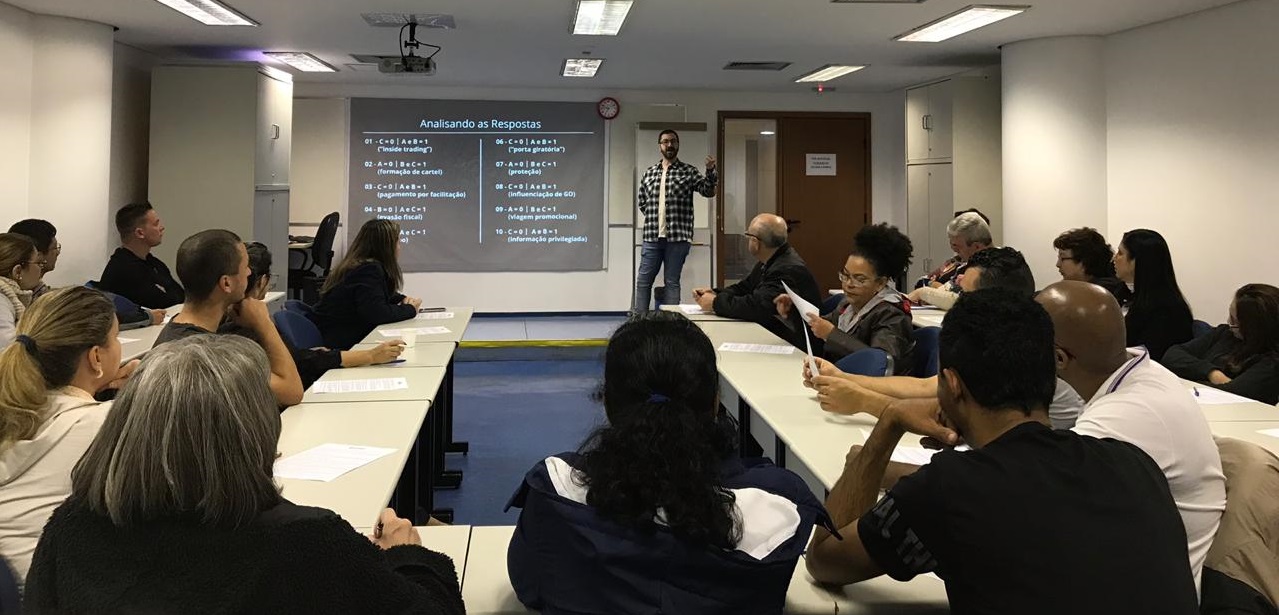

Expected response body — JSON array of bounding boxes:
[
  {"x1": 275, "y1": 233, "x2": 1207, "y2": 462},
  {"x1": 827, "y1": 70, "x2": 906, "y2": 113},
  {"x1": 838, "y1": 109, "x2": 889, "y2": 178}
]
[{"x1": 462, "y1": 525, "x2": 537, "y2": 615}]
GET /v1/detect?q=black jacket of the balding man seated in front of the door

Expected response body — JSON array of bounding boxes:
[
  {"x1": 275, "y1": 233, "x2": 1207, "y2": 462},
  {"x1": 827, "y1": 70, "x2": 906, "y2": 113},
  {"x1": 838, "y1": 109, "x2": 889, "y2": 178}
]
[{"x1": 714, "y1": 243, "x2": 821, "y2": 340}]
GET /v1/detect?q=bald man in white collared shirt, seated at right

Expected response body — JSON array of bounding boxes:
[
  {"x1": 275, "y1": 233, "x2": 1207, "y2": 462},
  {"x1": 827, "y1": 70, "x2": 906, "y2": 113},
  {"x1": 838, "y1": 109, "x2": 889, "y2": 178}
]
[{"x1": 1036, "y1": 281, "x2": 1225, "y2": 588}]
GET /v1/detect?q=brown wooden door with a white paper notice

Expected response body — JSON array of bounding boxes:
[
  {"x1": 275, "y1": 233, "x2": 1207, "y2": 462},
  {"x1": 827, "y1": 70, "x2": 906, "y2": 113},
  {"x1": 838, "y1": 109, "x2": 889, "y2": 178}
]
[{"x1": 778, "y1": 115, "x2": 871, "y2": 295}]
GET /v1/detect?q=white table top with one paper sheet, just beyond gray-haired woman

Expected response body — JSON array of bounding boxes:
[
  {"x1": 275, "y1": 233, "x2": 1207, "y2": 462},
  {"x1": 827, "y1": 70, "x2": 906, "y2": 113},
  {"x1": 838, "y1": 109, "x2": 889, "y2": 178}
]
[{"x1": 276, "y1": 400, "x2": 431, "y2": 528}]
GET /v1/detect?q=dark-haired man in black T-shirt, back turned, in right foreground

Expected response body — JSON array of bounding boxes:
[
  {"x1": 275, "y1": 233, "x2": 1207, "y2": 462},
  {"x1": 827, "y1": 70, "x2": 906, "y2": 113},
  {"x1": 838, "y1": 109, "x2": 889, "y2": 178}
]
[{"x1": 807, "y1": 289, "x2": 1198, "y2": 615}]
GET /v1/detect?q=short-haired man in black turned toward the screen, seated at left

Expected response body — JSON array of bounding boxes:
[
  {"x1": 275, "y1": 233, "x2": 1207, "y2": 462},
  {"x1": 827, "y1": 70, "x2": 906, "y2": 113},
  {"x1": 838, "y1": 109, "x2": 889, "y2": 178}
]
[{"x1": 98, "y1": 203, "x2": 185, "y2": 309}]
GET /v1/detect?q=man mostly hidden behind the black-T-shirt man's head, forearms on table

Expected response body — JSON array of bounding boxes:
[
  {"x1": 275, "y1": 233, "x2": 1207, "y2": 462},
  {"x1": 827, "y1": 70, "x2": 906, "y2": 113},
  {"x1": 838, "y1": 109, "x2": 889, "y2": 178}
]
[{"x1": 804, "y1": 248, "x2": 1083, "y2": 430}]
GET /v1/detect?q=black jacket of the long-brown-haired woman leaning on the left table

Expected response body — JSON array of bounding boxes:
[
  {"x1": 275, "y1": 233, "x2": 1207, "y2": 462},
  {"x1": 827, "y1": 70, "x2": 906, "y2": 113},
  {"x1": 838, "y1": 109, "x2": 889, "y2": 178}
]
[{"x1": 308, "y1": 261, "x2": 417, "y2": 350}]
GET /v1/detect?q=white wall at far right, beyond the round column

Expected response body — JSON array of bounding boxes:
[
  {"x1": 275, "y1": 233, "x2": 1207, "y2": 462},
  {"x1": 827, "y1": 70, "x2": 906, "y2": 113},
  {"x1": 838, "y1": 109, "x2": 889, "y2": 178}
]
[{"x1": 1106, "y1": 0, "x2": 1279, "y2": 322}]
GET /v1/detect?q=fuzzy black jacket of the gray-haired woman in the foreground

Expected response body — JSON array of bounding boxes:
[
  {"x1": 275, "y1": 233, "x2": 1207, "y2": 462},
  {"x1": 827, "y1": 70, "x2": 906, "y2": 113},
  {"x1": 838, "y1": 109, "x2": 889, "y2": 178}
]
[{"x1": 24, "y1": 500, "x2": 466, "y2": 615}]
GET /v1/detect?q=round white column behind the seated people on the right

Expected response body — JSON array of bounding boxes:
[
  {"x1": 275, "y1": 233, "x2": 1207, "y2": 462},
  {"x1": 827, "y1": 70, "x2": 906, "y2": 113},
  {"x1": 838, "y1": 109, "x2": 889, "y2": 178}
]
[{"x1": 997, "y1": 37, "x2": 1106, "y2": 288}]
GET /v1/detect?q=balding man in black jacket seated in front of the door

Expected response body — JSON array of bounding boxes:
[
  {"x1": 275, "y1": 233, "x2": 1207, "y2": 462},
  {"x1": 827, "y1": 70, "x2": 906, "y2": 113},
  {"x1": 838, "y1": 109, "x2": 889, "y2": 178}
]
[{"x1": 693, "y1": 214, "x2": 821, "y2": 340}]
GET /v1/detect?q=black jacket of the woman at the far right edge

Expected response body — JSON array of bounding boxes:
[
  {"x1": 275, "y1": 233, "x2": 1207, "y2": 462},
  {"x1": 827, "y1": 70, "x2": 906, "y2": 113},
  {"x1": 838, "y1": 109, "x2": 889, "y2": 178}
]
[{"x1": 1160, "y1": 325, "x2": 1279, "y2": 405}]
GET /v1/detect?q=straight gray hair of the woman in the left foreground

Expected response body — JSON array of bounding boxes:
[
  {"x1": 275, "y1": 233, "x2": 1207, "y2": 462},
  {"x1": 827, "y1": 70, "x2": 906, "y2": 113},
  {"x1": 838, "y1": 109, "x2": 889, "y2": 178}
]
[{"x1": 72, "y1": 335, "x2": 280, "y2": 527}]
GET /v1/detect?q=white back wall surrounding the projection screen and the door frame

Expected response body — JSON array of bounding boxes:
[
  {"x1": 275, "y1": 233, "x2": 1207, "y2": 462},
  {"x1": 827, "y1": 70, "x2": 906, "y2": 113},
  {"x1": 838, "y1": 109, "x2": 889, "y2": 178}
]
[{"x1": 290, "y1": 78, "x2": 906, "y2": 312}]
